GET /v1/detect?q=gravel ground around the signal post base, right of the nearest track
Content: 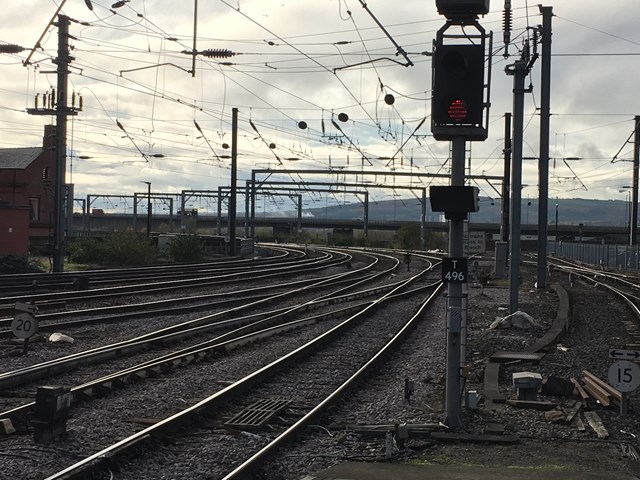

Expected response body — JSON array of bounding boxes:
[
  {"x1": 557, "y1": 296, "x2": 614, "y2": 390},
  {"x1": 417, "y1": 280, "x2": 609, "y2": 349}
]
[{"x1": 261, "y1": 264, "x2": 640, "y2": 480}]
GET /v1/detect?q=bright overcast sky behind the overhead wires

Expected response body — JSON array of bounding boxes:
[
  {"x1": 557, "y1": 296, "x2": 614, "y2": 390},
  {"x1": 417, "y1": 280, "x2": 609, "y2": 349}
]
[{"x1": 0, "y1": 0, "x2": 640, "y2": 213}]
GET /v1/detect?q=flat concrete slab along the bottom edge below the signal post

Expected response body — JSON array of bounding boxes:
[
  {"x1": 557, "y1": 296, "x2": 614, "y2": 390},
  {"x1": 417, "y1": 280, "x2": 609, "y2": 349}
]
[{"x1": 304, "y1": 463, "x2": 636, "y2": 480}]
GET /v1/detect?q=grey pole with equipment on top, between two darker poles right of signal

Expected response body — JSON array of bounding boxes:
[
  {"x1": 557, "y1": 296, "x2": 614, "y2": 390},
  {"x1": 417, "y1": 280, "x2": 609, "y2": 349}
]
[{"x1": 508, "y1": 60, "x2": 529, "y2": 313}]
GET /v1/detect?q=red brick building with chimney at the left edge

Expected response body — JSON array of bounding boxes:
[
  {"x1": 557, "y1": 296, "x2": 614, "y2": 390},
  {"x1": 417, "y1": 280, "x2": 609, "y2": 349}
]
[{"x1": 0, "y1": 125, "x2": 56, "y2": 255}]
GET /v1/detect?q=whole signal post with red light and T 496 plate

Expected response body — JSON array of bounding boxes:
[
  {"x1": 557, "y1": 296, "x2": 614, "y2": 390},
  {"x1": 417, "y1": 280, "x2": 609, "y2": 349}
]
[{"x1": 429, "y1": 0, "x2": 491, "y2": 428}]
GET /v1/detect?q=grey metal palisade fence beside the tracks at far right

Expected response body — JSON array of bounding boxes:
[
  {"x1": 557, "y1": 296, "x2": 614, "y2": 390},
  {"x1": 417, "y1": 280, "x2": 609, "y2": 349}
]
[{"x1": 548, "y1": 241, "x2": 640, "y2": 270}]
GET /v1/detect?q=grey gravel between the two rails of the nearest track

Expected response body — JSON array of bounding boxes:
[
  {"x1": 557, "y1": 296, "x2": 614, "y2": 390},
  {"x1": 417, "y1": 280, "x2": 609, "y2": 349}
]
[{"x1": 118, "y1": 290, "x2": 436, "y2": 480}]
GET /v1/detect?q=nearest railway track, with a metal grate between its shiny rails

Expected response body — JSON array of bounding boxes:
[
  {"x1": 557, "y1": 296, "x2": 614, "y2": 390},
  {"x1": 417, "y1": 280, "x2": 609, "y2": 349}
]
[{"x1": 42, "y1": 268, "x2": 439, "y2": 480}]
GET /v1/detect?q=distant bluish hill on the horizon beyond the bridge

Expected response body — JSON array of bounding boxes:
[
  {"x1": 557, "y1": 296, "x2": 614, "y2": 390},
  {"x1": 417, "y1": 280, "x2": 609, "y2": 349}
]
[{"x1": 303, "y1": 198, "x2": 630, "y2": 226}]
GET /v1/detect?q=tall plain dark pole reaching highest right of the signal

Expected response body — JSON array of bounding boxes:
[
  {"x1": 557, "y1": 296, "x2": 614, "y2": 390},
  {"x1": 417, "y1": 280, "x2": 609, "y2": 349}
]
[{"x1": 536, "y1": 6, "x2": 553, "y2": 288}]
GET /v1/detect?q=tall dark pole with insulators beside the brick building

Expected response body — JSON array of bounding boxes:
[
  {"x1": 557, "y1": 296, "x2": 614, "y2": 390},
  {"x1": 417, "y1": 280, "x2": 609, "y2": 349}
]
[{"x1": 53, "y1": 15, "x2": 69, "y2": 272}]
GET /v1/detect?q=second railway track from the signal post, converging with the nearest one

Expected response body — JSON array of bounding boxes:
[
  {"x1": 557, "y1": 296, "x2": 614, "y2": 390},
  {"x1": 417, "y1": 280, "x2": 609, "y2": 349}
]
[{"x1": 0, "y1": 248, "x2": 444, "y2": 478}]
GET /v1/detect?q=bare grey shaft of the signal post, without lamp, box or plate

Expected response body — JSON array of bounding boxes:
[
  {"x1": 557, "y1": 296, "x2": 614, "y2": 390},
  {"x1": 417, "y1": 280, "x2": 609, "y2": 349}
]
[{"x1": 444, "y1": 137, "x2": 466, "y2": 428}]
